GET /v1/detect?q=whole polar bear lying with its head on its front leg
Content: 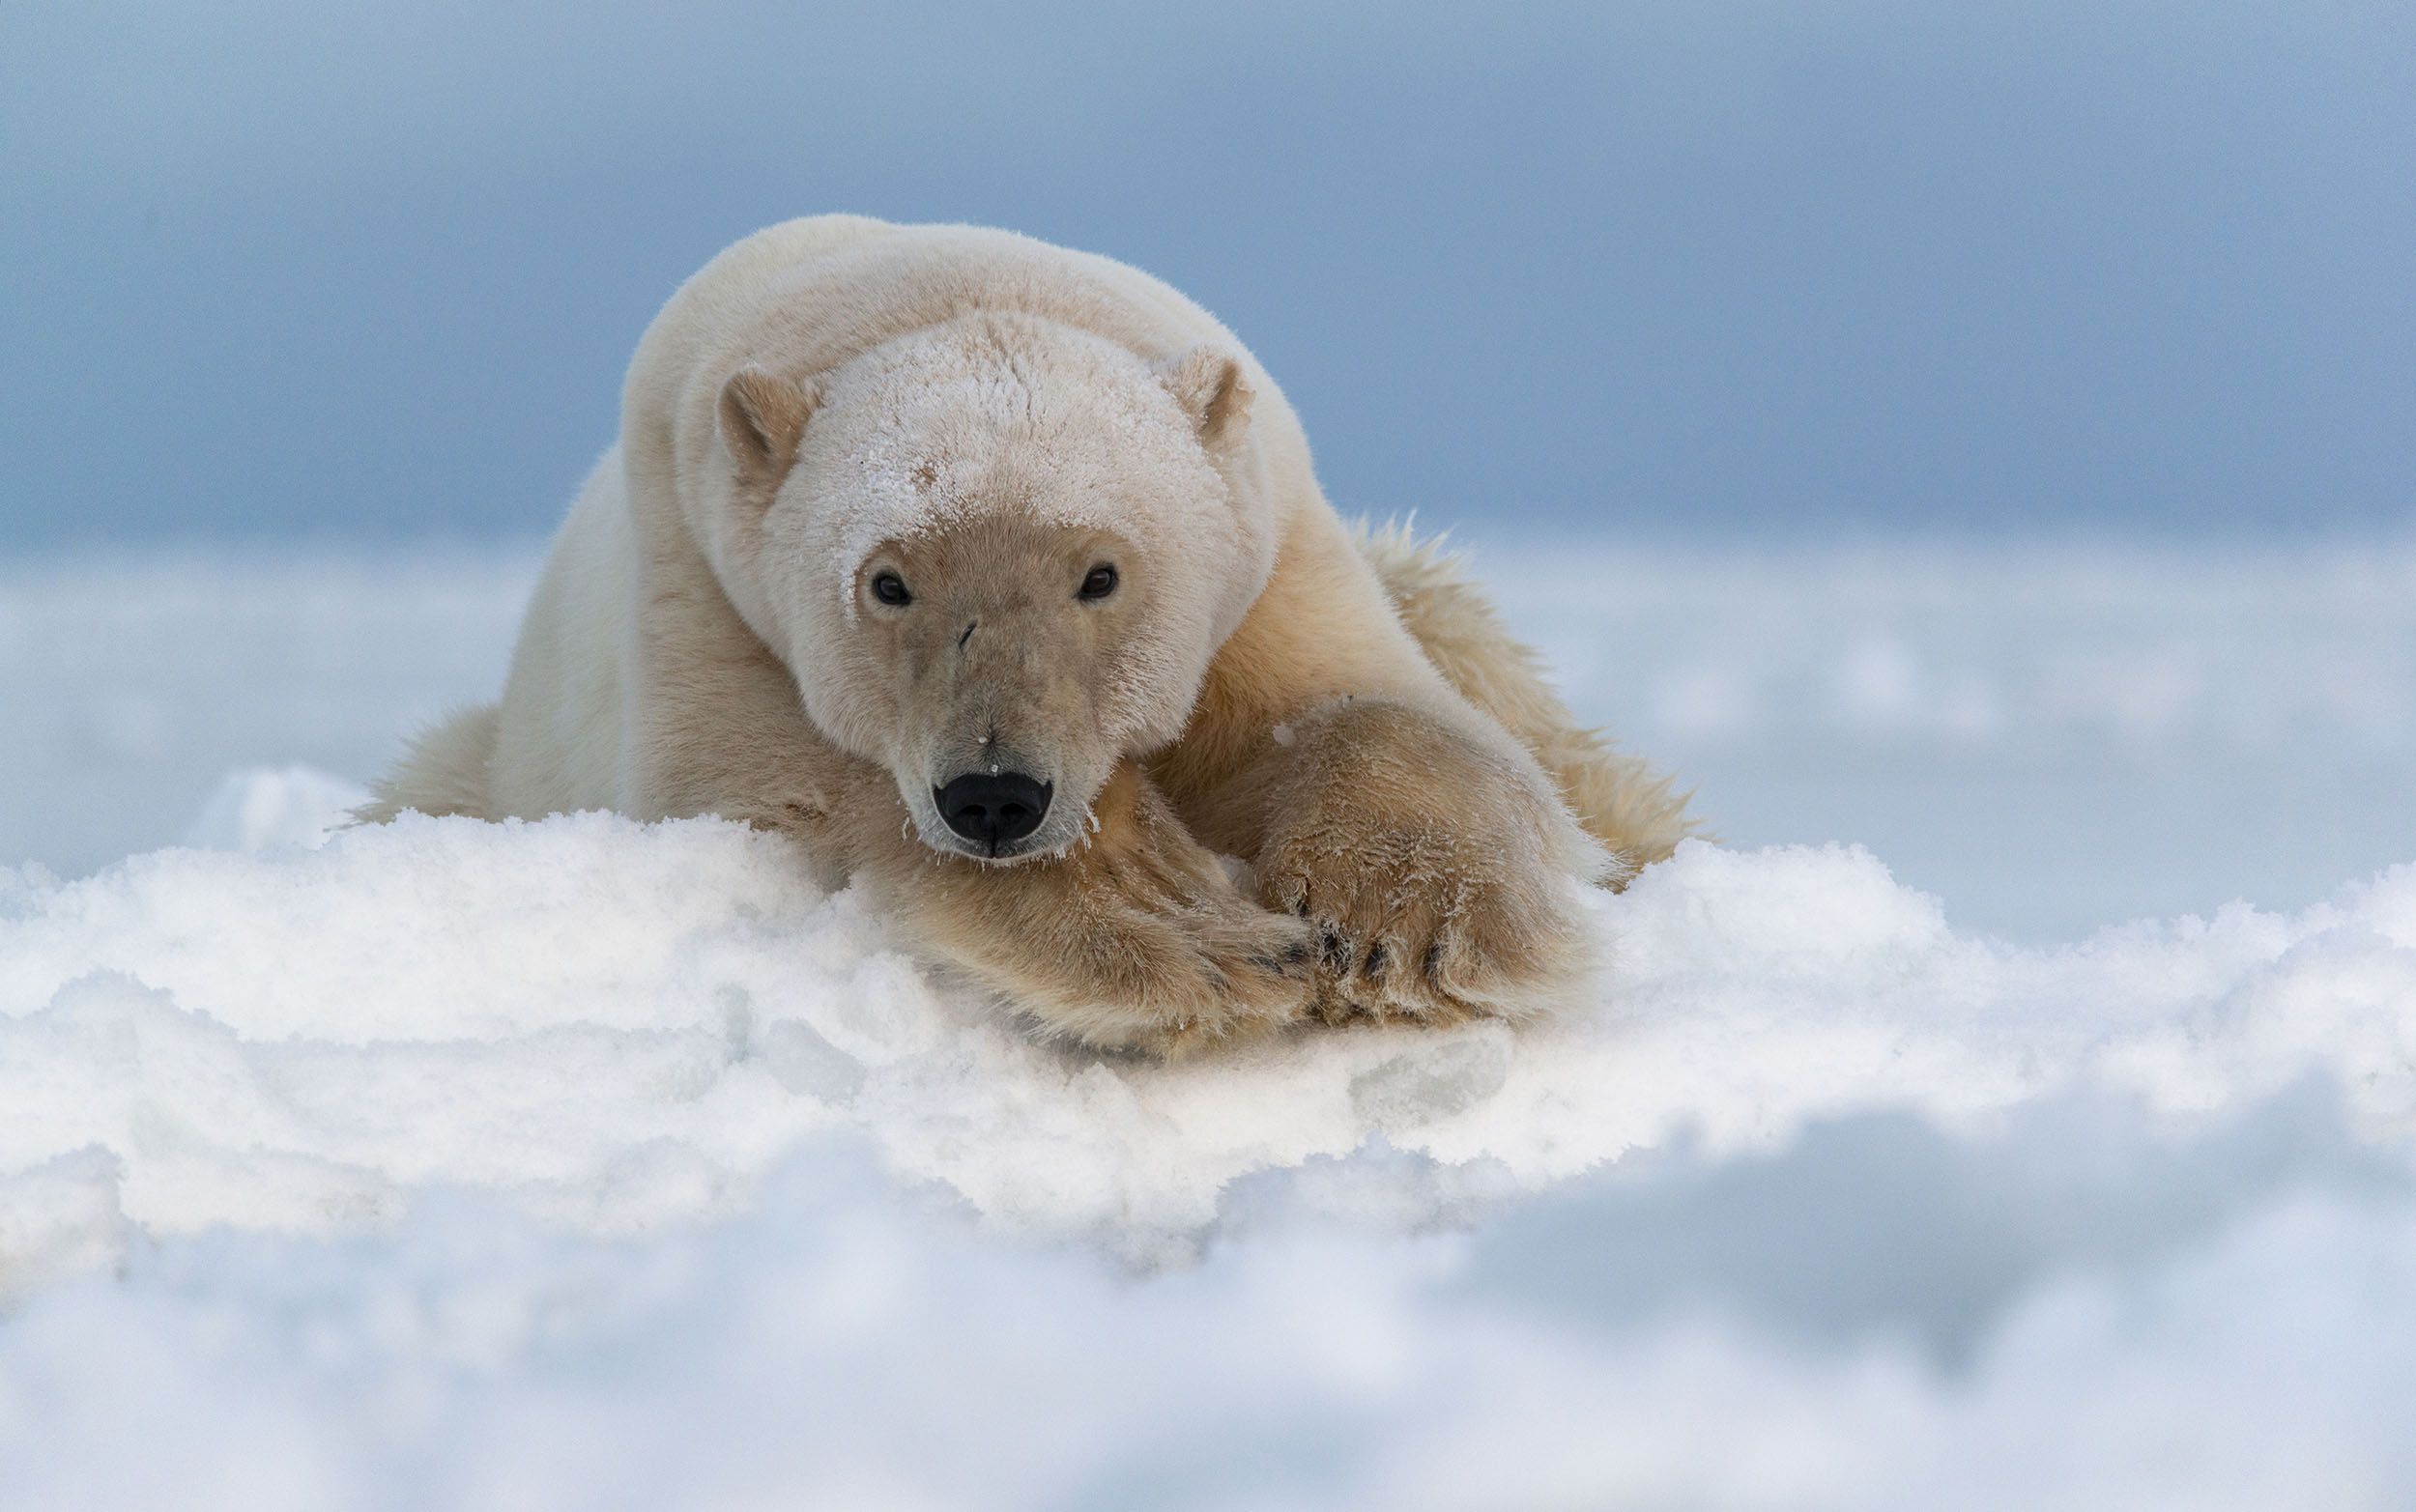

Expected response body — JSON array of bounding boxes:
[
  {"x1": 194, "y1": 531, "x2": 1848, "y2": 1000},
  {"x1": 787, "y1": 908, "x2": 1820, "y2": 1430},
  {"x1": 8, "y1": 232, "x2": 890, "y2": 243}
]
[{"x1": 362, "y1": 215, "x2": 1689, "y2": 1051}]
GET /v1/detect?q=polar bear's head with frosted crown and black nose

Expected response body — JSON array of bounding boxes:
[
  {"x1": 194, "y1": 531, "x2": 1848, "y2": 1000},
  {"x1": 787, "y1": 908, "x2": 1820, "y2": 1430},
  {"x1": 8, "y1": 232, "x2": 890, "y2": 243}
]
[{"x1": 715, "y1": 312, "x2": 1276, "y2": 863}]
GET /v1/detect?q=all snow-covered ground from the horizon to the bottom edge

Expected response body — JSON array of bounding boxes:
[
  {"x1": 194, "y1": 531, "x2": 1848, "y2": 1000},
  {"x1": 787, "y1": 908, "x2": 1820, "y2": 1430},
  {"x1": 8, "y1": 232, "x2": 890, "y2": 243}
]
[{"x1": 0, "y1": 536, "x2": 2416, "y2": 1510}]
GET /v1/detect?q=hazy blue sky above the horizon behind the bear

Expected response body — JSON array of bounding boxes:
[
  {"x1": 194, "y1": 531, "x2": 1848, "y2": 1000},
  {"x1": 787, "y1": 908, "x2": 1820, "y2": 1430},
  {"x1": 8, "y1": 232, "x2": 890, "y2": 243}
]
[{"x1": 0, "y1": 0, "x2": 2416, "y2": 546}]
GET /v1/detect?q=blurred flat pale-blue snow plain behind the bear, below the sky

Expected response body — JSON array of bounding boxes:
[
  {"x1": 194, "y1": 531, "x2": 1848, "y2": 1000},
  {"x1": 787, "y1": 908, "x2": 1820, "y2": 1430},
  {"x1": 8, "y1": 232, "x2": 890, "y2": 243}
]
[{"x1": 0, "y1": 536, "x2": 2416, "y2": 942}]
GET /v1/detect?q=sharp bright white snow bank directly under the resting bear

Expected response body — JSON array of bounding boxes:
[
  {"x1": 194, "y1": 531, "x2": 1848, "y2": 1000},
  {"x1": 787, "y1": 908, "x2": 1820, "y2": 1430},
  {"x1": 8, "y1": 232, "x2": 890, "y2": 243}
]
[{"x1": 0, "y1": 783, "x2": 2416, "y2": 1264}]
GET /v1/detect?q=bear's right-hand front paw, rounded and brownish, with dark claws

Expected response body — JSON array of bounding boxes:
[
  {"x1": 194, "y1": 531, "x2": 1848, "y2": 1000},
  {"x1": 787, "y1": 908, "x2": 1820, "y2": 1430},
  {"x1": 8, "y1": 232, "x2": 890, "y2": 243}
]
[{"x1": 1259, "y1": 703, "x2": 1590, "y2": 1024}]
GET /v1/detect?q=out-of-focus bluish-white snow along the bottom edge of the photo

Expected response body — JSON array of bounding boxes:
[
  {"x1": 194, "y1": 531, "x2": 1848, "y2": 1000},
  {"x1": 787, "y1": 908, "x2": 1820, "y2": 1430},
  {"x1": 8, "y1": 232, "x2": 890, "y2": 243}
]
[{"x1": 0, "y1": 1099, "x2": 2416, "y2": 1512}]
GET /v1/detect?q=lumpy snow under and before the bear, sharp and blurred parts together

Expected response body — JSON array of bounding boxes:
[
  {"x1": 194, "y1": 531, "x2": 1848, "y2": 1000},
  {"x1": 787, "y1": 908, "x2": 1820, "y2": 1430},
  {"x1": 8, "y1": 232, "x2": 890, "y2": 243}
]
[{"x1": 0, "y1": 773, "x2": 2416, "y2": 1510}]
